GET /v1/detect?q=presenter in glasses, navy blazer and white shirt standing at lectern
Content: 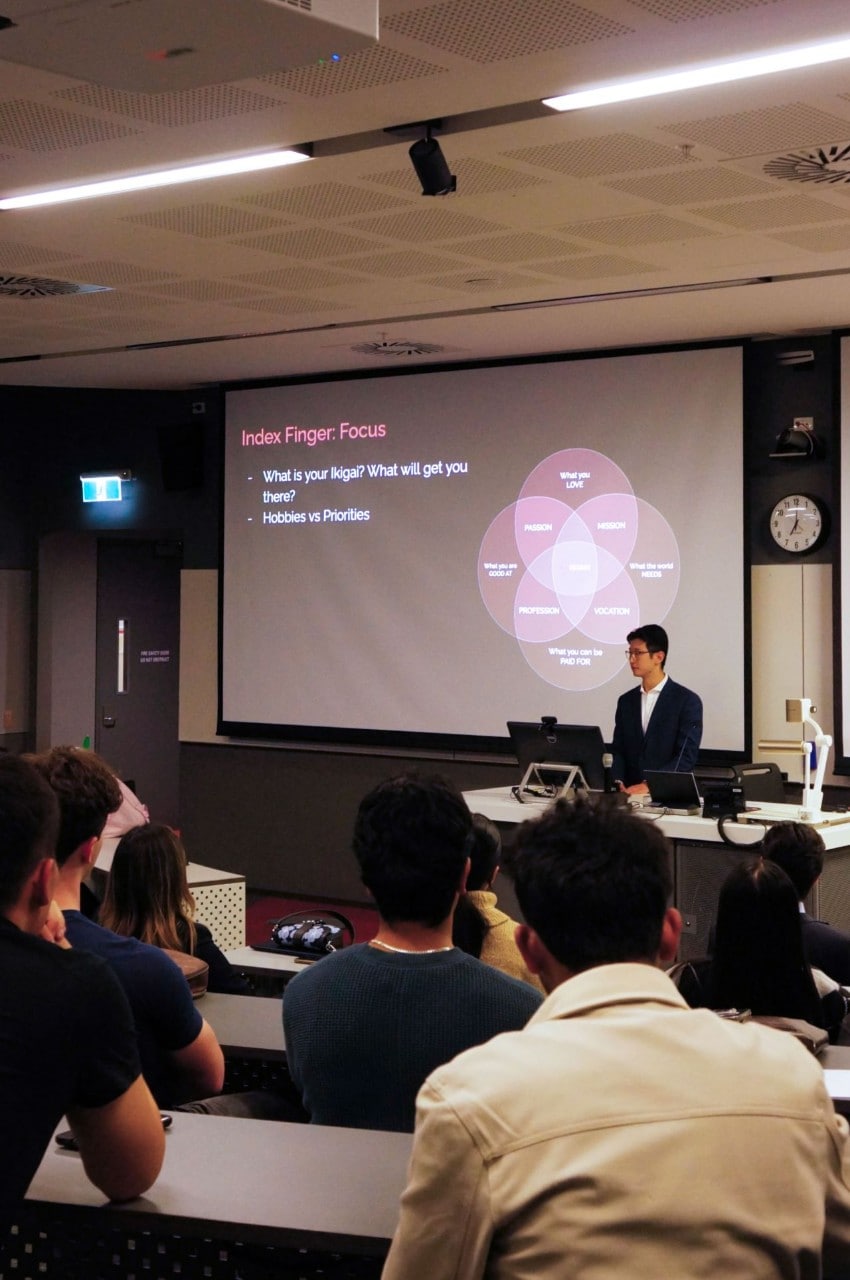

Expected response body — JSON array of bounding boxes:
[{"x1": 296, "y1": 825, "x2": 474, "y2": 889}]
[{"x1": 612, "y1": 623, "x2": 703, "y2": 795}]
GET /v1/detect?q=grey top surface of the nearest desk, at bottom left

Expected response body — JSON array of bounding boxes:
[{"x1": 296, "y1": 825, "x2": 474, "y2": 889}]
[{"x1": 27, "y1": 1112, "x2": 412, "y2": 1252}]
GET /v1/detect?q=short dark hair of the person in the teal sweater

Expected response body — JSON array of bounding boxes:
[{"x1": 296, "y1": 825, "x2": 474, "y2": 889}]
[{"x1": 353, "y1": 774, "x2": 472, "y2": 927}]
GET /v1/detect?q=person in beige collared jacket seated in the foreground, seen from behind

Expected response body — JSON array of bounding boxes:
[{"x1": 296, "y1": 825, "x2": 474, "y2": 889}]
[{"x1": 384, "y1": 801, "x2": 850, "y2": 1280}]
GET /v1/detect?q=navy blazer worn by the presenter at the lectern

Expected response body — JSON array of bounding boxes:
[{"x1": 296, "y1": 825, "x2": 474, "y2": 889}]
[{"x1": 612, "y1": 678, "x2": 703, "y2": 787}]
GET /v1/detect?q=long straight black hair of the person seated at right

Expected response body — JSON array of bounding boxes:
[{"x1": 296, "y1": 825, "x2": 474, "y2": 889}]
[{"x1": 708, "y1": 858, "x2": 823, "y2": 1027}]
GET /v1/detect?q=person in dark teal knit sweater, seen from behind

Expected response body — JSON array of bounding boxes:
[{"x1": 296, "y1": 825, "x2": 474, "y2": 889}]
[{"x1": 283, "y1": 777, "x2": 540, "y2": 1130}]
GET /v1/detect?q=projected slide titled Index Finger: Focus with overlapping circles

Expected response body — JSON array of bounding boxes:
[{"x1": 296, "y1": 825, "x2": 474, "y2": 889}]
[{"x1": 220, "y1": 346, "x2": 746, "y2": 754}]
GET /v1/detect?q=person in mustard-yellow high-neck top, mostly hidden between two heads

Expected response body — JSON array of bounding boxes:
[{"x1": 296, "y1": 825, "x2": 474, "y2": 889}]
[{"x1": 452, "y1": 813, "x2": 543, "y2": 992}]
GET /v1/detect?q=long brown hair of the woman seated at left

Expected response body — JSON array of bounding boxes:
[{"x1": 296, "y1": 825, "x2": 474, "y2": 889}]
[{"x1": 97, "y1": 822, "x2": 197, "y2": 954}]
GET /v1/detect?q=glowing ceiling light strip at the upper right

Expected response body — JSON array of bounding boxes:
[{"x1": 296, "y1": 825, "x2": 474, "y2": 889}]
[{"x1": 543, "y1": 37, "x2": 850, "y2": 111}]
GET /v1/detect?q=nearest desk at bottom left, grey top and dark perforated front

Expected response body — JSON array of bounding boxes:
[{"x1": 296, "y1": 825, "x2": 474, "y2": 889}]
[{"x1": 3, "y1": 1112, "x2": 412, "y2": 1280}]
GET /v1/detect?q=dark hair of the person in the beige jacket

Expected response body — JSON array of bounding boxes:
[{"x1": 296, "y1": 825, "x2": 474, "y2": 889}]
[{"x1": 504, "y1": 799, "x2": 672, "y2": 973}]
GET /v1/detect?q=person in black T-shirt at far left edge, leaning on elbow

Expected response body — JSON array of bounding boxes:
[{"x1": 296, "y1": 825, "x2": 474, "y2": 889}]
[{"x1": 0, "y1": 755, "x2": 165, "y2": 1252}]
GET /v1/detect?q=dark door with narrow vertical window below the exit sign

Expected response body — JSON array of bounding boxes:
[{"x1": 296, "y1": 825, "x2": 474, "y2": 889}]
[{"x1": 93, "y1": 539, "x2": 182, "y2": 827}]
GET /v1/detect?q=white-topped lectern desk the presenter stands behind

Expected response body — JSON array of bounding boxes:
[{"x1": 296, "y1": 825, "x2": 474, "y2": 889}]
[{"x1": 463, "y1": 787, "x2": 850, "y2": 960}]
